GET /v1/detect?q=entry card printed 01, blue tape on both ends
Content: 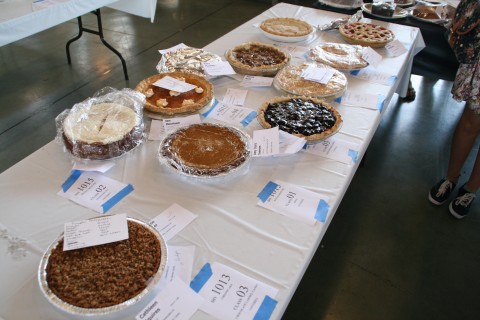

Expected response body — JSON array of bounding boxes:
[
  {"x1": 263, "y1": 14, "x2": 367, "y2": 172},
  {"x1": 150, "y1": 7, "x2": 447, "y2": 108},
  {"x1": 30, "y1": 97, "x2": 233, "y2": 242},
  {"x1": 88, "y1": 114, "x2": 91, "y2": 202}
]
[{"x1": 257, "y1": 181, "x2": 330, "y2": 225}]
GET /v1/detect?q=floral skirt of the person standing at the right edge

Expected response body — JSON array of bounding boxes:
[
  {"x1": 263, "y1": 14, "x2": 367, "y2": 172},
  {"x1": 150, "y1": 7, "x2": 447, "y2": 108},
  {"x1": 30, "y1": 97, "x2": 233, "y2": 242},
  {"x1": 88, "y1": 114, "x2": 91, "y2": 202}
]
[{"x1": 452, "y1": 61, "x2": 480, "y2": 116}]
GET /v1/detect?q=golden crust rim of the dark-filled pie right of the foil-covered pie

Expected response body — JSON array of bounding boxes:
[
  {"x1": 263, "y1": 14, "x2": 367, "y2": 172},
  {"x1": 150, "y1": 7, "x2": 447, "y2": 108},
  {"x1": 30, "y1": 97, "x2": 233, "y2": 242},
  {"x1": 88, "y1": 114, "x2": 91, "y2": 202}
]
[{"x1": 227, "y1": 42, "x2": 290, "y2": 76}]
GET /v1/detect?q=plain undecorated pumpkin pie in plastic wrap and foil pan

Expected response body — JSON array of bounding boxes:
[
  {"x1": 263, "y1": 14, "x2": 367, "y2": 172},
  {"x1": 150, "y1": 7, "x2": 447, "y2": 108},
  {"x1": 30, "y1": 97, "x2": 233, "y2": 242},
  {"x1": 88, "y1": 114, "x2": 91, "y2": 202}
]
[{"x1": 159, "y1": 123, "x2": 251, "y2": 178}]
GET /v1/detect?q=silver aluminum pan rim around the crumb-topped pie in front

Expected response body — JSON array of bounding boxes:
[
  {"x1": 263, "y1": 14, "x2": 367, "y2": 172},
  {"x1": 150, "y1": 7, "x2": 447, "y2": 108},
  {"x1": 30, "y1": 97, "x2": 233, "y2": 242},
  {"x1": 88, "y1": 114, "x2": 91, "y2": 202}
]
[{"x1": 38, "y1": 216, "x2": 168, "y2": 316}]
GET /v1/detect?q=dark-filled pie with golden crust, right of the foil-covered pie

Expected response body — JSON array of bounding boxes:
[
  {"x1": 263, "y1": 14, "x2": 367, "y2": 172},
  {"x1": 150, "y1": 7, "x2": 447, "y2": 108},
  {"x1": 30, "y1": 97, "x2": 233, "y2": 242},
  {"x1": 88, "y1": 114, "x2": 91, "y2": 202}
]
[{"x1": 227, "y1": 42, "x2": 290, "y2": 76}]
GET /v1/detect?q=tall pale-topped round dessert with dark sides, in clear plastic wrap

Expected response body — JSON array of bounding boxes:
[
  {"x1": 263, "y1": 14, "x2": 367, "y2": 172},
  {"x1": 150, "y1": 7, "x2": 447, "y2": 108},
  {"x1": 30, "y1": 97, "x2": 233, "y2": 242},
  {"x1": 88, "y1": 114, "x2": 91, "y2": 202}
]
[{"x1": 62, "y1": 103, "x2": 143, "y2": 160}]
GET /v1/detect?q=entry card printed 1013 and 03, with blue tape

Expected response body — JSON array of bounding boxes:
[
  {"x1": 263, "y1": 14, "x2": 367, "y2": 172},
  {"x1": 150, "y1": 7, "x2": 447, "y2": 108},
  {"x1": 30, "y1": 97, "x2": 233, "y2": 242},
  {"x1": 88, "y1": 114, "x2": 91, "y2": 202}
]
[{"x1": 190, "y1": 262, "x2": 278, "y2": 320}]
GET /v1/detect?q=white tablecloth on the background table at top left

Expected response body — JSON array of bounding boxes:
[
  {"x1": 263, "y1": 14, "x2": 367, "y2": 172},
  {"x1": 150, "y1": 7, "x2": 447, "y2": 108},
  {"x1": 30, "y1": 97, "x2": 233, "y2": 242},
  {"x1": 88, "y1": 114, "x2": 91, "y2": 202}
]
[{"x1": 0, "y1": 0, "x2": 157, "y2": 46}]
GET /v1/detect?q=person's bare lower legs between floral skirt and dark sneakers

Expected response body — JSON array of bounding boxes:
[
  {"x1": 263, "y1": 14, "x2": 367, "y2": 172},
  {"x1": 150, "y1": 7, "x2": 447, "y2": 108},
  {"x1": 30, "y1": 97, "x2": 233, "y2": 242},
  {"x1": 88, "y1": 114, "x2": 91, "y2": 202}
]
[{"x1": 447, "y1": 104, "x2": 480, "y2": 184}]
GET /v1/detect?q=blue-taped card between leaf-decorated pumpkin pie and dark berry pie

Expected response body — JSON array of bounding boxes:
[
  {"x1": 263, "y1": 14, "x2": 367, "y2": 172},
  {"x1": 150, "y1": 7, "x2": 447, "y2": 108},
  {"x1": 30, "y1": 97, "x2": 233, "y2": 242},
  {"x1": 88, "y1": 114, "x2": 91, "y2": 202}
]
[{"x1": 203, "y1": 101, "x2": 257, "y2": 127}]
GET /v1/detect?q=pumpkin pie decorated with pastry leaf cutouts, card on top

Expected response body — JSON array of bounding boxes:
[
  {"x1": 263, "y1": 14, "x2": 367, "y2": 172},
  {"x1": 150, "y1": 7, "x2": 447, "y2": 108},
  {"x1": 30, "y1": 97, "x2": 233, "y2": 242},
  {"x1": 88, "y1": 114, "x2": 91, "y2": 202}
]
[{"x1": 135, "y1": 72, "x2": 213, "y2": 115}]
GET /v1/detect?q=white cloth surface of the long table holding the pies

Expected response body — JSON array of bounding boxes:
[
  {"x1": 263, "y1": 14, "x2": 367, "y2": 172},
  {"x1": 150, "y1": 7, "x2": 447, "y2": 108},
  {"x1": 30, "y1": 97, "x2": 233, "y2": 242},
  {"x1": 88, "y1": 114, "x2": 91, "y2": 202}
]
[{"x1": 0, "y1": 3, "x2": 424, "y2": 320}]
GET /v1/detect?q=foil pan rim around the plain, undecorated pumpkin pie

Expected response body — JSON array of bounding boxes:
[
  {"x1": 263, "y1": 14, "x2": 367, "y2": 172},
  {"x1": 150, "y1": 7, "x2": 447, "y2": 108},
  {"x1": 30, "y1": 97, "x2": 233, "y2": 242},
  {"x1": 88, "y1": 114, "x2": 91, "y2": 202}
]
[{"x1": 157, "y1": 122, "x2": 252, "y2": 181}]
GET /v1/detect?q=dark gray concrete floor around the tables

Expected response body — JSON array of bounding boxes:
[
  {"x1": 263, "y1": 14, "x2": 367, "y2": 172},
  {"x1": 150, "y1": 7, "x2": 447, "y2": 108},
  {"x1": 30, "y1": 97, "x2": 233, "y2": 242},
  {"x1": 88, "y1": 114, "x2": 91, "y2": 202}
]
[{"x1": 0, "y1": 0, "x2": 480, "y2": 320}]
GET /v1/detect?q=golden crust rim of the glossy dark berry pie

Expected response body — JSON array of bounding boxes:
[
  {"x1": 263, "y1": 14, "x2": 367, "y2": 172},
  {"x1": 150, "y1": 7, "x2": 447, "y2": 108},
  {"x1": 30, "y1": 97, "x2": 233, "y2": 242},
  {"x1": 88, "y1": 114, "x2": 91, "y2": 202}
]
[{"x1": 257, "y1": 96, "x2": 342, "y2": 141}]
